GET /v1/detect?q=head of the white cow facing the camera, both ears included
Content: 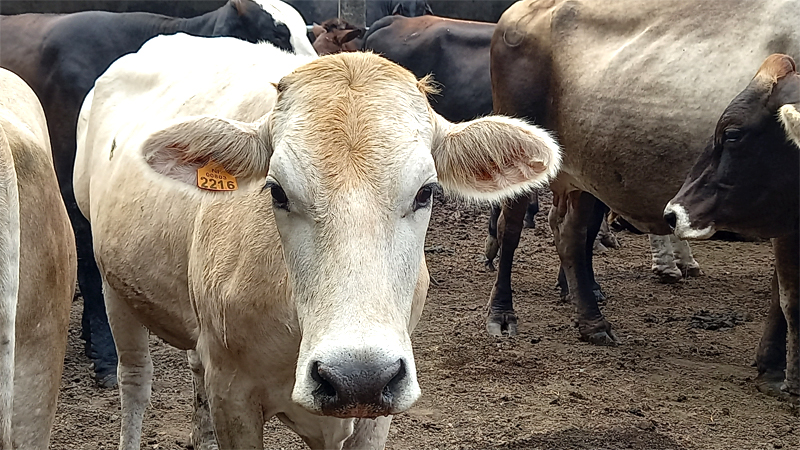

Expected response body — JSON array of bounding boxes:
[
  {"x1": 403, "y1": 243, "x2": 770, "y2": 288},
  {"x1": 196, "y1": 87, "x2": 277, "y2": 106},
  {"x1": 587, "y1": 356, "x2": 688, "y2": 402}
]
[{"x1": 143, "y1": 52, "x2": 561, "y2": 417}]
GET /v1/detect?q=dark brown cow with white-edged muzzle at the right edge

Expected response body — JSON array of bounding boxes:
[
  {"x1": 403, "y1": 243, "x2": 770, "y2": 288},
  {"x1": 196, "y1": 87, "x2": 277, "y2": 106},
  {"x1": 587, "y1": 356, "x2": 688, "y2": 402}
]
[{"x1": 664, "y1": 54, "x2": 800, "y2": 400}]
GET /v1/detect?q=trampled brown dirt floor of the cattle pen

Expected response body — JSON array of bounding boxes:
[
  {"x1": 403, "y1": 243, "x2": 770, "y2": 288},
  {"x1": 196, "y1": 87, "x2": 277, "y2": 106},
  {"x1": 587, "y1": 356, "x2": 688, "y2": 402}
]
[{"x1": 51, "y1": 192, "x2": 800, "y2": 450}]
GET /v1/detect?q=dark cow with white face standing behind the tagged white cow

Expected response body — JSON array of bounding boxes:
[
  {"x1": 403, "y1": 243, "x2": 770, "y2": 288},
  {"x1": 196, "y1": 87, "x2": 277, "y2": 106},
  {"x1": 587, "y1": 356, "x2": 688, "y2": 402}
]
[{"x1": 0, "y1": 0, "x2": 313, "y2": 386}]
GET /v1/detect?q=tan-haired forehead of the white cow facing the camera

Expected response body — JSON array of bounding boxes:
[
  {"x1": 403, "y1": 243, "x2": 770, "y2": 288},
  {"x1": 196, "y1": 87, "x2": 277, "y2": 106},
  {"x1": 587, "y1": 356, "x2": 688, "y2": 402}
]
[{"x1": 272, "y1": 53, "x2": 433, "y2": 190}]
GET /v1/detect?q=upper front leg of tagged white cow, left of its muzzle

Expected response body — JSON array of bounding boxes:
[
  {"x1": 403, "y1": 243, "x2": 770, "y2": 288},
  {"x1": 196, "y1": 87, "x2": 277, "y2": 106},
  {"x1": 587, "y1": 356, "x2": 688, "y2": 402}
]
[{"x1": 205, "y1": 364, "x2": 264, "y2": 450}]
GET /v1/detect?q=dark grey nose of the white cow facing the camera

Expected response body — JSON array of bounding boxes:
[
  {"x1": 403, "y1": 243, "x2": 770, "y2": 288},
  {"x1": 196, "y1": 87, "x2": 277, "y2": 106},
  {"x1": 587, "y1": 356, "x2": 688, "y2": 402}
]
[{"x1": 311, "y1": 359, "x2": 406, "y2": 418}]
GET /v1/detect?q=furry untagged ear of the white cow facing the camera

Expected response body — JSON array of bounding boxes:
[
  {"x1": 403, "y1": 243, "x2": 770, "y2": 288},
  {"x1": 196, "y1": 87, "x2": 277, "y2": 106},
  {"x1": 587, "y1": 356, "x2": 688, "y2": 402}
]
[{"x1": 431, "y1": 111, "x2": 561, "y2": 201}]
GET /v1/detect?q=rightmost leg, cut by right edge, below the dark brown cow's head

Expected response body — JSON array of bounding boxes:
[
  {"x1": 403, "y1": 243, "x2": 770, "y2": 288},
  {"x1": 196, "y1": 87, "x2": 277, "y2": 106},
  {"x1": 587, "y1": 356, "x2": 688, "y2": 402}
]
[{"x1": 772, "y1": 233, "x2": 800, "y2": 400}]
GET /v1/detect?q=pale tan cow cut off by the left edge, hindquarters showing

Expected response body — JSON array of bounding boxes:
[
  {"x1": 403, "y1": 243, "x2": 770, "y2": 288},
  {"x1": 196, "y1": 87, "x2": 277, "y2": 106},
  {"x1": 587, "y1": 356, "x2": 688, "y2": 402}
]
[{"x1": 0, "y1": 69, "x2": 77, "y2": 450}]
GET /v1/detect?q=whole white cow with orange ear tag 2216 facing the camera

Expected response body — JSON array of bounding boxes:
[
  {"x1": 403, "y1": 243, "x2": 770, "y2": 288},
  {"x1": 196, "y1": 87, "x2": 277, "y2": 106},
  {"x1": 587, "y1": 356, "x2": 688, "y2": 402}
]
[{"x1": 74, "y1": 35, "x2": 560, "y2": 449}]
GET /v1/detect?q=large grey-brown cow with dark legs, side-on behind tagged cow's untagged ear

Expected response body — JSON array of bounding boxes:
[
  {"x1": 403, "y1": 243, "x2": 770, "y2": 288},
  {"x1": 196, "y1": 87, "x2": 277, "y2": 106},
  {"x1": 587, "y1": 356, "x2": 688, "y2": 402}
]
[{"x1": 489, "y1": 0, "x2": 800, "y2": 345}]
